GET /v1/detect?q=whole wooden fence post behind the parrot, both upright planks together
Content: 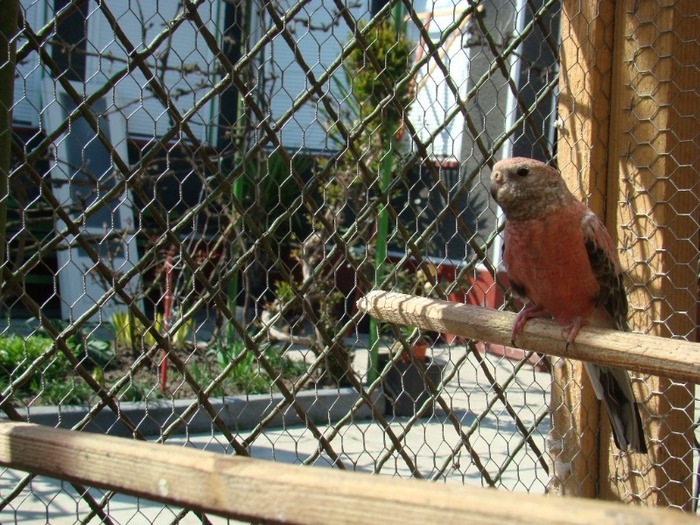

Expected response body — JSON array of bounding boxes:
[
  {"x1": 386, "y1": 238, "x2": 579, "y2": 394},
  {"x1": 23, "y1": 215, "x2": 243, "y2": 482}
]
[{"x1": 552, "y1": 0, "x2": 700, "y2": 508}]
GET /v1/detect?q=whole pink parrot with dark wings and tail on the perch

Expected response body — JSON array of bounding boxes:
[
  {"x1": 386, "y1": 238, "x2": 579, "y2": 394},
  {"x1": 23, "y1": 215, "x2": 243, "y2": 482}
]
[{"x1": 491, "y1": 158, "x2": 647, "y2": 453}]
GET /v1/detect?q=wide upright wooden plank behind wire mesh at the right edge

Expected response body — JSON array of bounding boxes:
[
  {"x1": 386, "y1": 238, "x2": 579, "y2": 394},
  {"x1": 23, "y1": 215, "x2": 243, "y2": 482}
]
[{"x1": 601, "y1": 0, "x2": 700, "y2": 509}]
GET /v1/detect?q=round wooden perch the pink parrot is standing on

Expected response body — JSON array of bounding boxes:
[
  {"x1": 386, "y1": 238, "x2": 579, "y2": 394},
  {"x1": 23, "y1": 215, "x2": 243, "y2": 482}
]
[{"x1": 358, "y1": 290, "x2": 700, "y2": 383}]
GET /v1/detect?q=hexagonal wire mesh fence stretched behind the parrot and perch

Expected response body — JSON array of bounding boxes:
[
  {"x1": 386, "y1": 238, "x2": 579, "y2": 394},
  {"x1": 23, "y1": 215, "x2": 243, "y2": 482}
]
[{"x1": 0, "y1": 0, "x2": 700, "y2": 523}]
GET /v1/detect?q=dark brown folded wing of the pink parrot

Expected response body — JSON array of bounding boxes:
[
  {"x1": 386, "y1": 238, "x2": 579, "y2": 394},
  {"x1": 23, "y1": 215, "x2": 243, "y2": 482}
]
[{"x1": 581, "y1": 210, "x2": 629, "y2": 332}]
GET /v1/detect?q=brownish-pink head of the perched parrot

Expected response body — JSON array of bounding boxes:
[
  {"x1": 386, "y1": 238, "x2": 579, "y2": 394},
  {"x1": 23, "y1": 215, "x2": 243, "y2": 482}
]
[{"x1": 491, "y1": 157, "x2": 574, "y2": 220}]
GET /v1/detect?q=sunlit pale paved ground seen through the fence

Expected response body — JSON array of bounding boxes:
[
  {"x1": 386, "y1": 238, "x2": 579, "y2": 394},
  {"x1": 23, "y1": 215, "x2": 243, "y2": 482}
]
[{"x1": 0, "y1": 348, "x2": 549, "y2": 525}]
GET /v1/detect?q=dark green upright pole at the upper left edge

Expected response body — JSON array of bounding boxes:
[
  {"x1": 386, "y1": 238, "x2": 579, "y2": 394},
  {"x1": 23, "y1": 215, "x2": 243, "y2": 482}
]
[{"x1": 0, "y1": 0, "x2": 19, "y2": 288}]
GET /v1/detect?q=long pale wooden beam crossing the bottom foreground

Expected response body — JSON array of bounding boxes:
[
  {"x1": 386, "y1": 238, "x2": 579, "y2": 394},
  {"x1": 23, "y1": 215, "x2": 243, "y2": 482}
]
[{"x1": 0, "y1": 423, "x2": 697, "y2": 525}]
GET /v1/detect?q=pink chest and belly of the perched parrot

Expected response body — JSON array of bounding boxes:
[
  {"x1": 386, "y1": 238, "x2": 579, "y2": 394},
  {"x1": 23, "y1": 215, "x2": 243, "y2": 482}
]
[{"x1": 504, "y1": 212, "x2": 600, "y2": 324}]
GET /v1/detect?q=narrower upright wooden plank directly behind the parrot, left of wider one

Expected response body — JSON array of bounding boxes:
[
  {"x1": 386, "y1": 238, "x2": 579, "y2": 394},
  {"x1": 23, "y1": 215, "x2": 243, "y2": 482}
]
[{"x1": 548, "y1": 0, "x2": 615, "y2": 497}]
